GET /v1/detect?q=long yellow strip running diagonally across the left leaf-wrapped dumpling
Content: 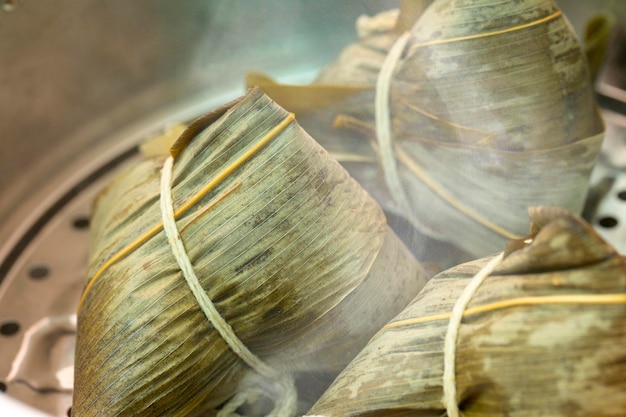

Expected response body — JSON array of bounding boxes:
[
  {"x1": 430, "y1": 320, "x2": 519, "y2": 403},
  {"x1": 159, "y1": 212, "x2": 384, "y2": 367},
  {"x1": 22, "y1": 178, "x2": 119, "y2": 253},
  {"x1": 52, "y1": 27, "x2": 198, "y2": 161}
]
[{"x1": 78, "y1": 113, "x2": 295, "y2": 311}]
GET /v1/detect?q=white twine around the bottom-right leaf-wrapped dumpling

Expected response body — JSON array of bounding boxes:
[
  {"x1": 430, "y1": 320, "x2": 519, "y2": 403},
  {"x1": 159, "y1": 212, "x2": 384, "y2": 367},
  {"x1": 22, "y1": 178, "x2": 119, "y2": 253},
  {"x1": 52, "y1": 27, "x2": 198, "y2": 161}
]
[{"x1": 443, "y1": 253, "x2": 504, "y2": 417}]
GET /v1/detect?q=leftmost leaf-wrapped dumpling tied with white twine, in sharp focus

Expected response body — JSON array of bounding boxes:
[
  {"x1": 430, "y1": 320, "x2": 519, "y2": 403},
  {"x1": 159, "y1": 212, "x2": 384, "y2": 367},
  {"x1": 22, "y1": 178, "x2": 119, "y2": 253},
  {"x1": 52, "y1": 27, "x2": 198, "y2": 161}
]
[{"x1": 72, "y1": 89, "x2": 425, "y2": 417}]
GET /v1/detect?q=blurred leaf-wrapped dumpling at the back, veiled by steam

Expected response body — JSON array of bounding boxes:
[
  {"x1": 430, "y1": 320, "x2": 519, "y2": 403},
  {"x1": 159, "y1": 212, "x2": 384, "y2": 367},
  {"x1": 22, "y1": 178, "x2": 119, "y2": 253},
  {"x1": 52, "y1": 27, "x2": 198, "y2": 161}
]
[{"x1": 246, "y1": 0, "x2": 604, "y2": 264}]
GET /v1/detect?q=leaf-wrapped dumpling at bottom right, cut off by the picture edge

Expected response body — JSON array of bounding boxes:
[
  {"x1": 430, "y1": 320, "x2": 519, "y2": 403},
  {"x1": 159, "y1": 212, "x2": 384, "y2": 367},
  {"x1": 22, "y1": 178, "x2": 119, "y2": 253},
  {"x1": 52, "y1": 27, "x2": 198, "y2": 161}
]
[{"x1": 310, "y1": 207, "x2": 626, "y2": 417}]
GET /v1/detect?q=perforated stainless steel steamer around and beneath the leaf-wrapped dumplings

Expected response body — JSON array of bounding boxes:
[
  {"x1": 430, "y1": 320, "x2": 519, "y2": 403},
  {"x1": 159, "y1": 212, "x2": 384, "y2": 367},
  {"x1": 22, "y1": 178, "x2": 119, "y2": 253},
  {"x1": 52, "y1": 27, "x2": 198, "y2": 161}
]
[{"x1": 0, "y1": 0, "x2": 626, "y2": 417}]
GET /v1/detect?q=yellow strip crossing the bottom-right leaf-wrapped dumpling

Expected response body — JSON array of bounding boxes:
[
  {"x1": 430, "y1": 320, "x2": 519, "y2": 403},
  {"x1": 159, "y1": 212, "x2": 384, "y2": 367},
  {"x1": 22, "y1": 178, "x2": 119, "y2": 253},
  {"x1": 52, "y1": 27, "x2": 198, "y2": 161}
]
[{"x1": 378, "y1": 293, "x2": 626, "y2": 333}]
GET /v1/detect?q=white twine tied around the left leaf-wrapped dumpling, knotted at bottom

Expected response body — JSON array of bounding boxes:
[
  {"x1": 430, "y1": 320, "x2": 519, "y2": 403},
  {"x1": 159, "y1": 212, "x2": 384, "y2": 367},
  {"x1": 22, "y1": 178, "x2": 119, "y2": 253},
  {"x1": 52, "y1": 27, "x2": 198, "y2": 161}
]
[{"x1": 160, "y1": 156, "x2": 297, "y2": 417}]
